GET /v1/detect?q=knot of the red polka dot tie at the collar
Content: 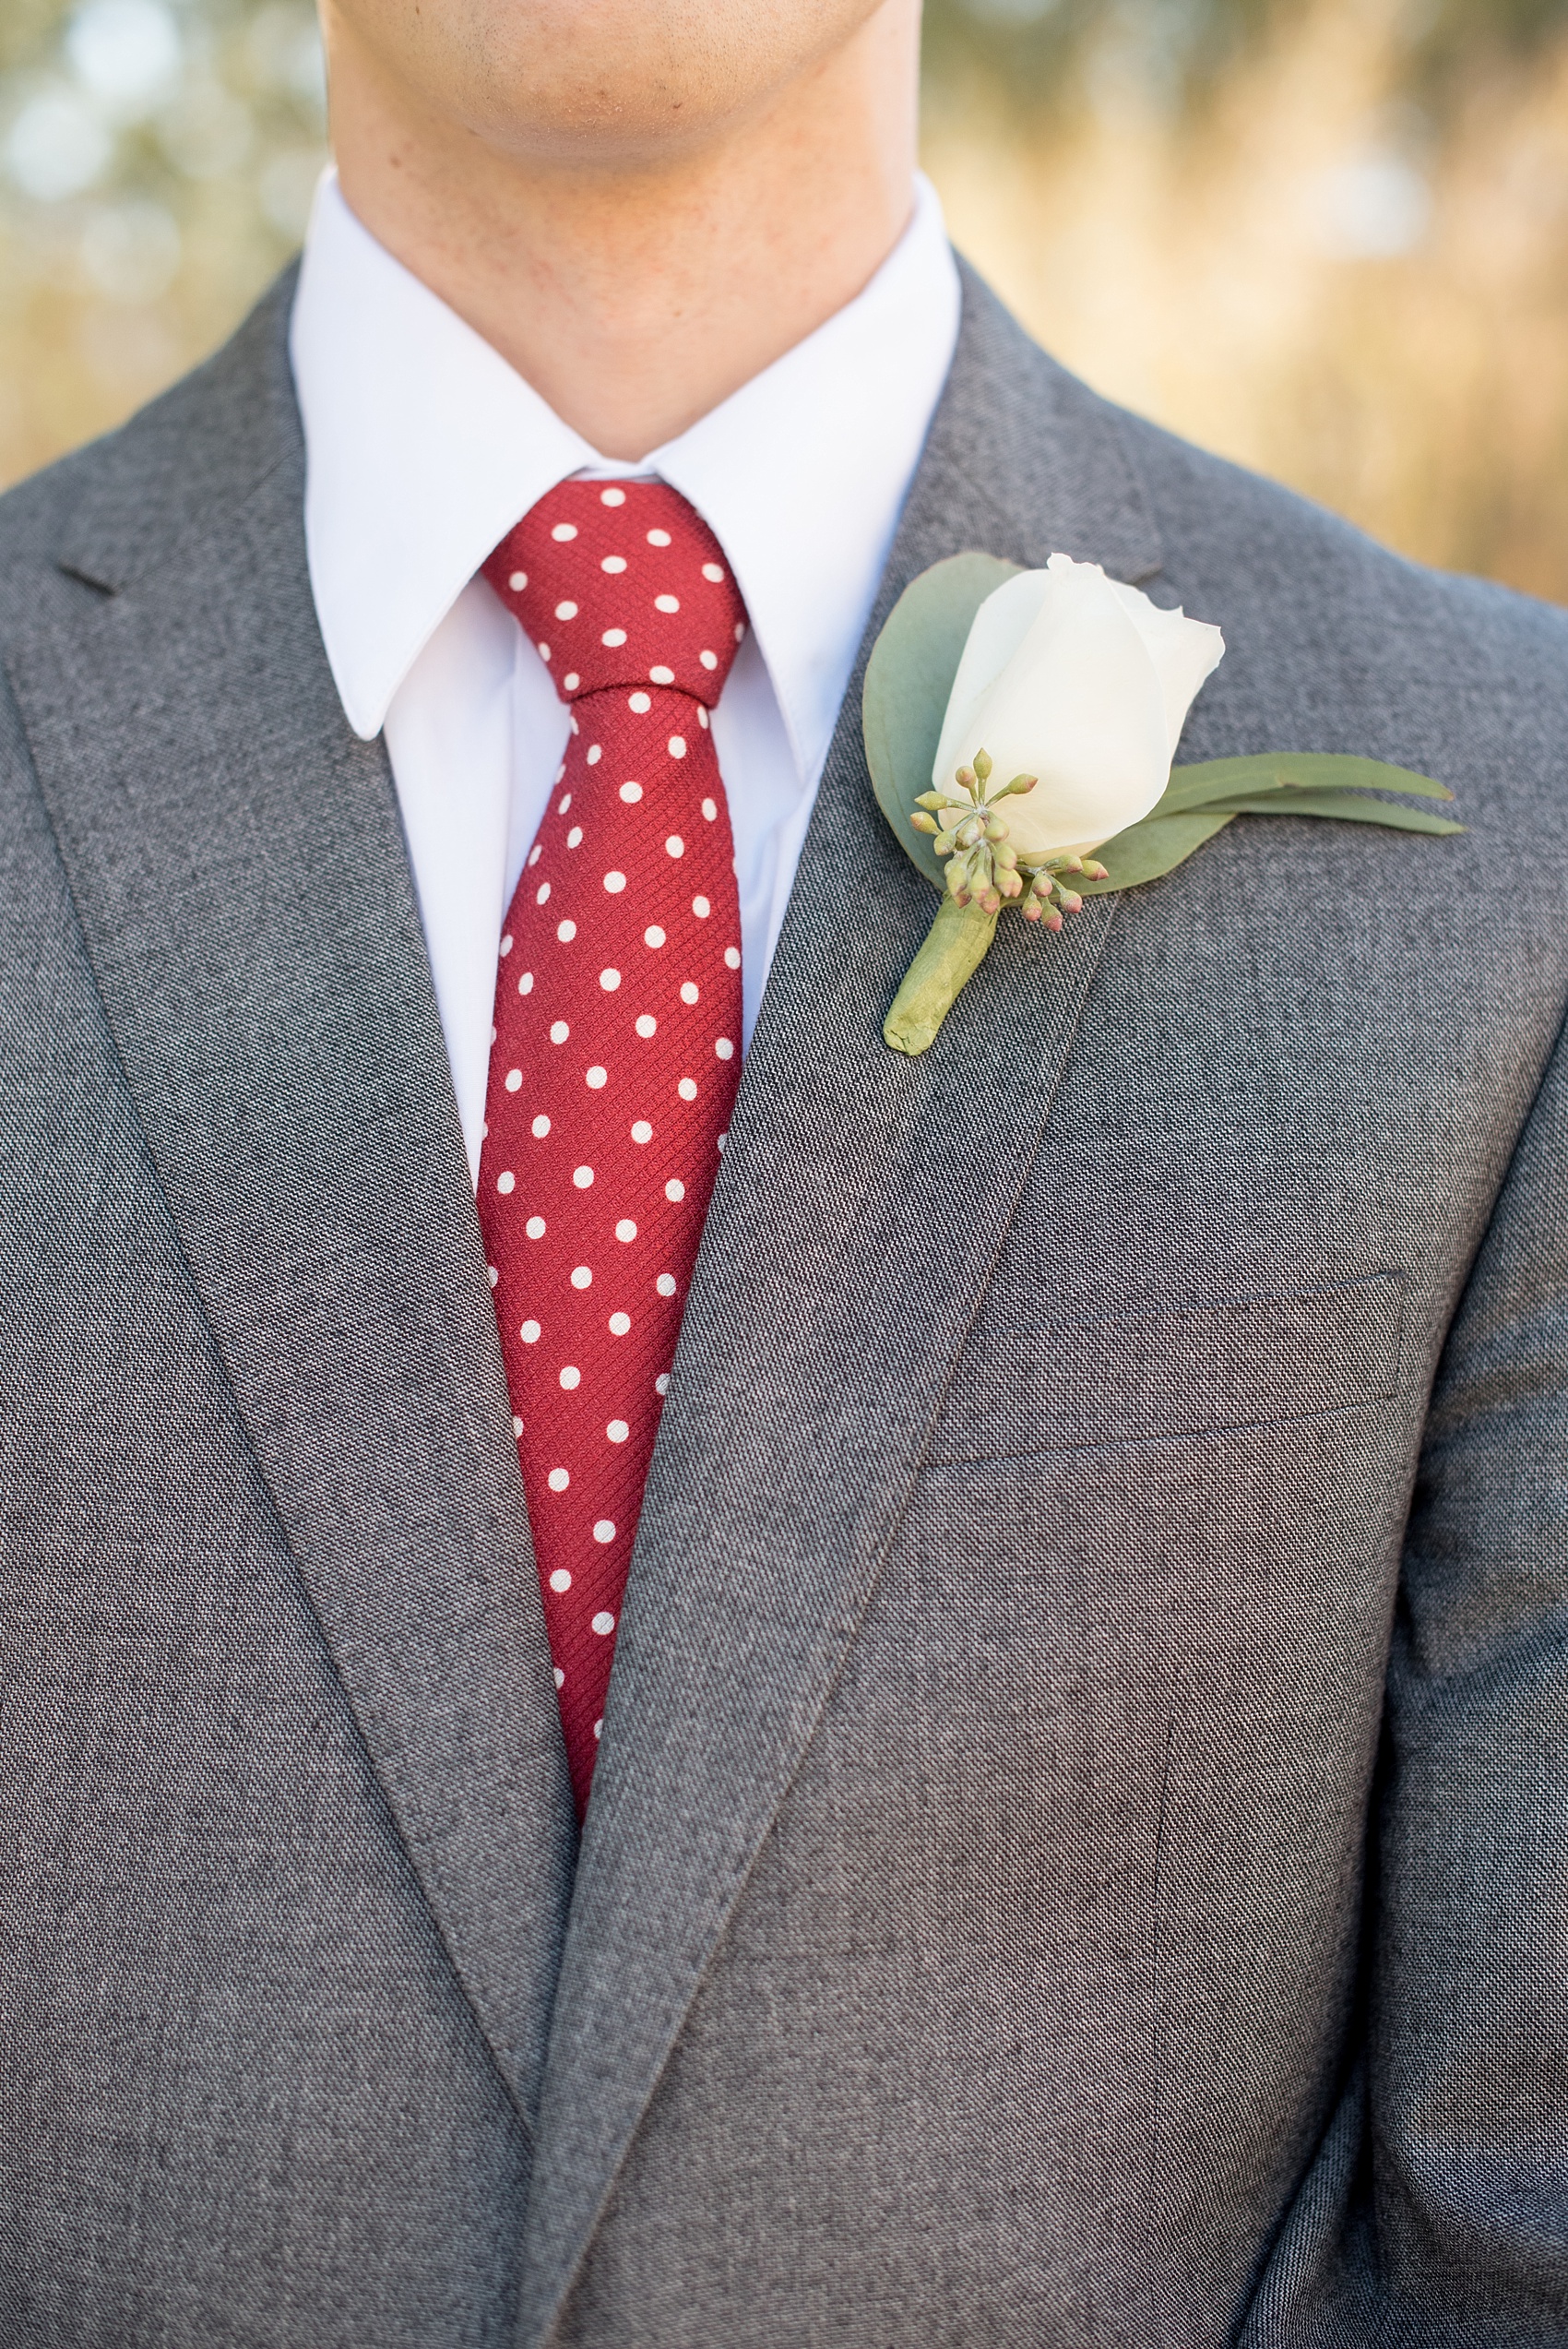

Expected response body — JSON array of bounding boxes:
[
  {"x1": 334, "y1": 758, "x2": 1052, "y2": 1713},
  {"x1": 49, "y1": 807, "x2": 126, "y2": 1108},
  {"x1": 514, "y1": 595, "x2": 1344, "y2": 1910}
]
[{"x1": 483, "y1": 482, "x2": 746, "y2": 709}]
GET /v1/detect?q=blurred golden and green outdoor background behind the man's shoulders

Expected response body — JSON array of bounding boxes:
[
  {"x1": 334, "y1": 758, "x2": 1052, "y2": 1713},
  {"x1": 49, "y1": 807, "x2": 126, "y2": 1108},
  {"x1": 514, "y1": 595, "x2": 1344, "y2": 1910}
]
[{"x1": 0, "y1": 0, "x2": 1568, "y2": 602}]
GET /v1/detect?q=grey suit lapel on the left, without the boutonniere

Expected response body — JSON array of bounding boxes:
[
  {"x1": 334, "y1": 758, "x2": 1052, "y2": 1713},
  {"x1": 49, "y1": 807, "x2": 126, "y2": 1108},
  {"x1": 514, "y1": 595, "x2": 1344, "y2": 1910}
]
[{"x1": 12, "y1": 287, "x2": 576, "y2": 2114}]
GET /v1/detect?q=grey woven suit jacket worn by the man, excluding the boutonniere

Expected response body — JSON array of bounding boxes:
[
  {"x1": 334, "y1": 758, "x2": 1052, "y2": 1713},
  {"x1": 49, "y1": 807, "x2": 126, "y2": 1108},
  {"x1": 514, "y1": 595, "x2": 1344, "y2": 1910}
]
[{"x1": 0, "y1": 256, "x2": 1568, "y2": 2349}]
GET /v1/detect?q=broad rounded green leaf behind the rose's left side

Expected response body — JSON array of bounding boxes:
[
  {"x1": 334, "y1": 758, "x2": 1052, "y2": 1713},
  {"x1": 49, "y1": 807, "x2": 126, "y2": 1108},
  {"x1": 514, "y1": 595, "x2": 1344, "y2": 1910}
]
[{"x1": 861, "y1": 552, "x2": 1018, "y2": 888}]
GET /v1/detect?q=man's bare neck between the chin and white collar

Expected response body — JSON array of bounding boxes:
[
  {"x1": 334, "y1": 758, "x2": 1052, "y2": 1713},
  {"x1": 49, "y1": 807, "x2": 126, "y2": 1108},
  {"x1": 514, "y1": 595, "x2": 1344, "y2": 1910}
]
[{"x1": 333, "y1": 9, "x2": 918, "y2": 463}]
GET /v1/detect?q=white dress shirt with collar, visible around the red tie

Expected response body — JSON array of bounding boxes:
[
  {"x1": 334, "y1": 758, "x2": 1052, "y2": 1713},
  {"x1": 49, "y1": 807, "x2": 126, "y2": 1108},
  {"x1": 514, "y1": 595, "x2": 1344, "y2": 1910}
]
[{"x1": 289, "y1": 172, "x2": 957, "y2": 1179}]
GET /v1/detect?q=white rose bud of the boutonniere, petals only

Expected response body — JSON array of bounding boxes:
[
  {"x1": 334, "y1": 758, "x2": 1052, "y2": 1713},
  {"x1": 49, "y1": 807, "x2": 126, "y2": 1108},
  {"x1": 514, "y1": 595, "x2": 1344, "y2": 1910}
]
[{"x1": 932, "y1": 554, "x2": 1225, "y2": 857}]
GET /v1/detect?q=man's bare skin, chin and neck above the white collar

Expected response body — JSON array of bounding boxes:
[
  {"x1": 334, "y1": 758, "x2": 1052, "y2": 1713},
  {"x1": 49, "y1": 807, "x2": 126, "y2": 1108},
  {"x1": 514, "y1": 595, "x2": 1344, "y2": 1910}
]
[{"x1": 322, "y1": 0, "x2": 921, "y2": 463}]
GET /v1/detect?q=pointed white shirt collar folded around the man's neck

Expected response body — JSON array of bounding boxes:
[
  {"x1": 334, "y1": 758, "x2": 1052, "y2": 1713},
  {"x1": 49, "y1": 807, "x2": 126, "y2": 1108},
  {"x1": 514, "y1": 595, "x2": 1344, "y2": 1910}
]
[{"x1": 289, "y1": 172, "x2": 960, "y2": 778}]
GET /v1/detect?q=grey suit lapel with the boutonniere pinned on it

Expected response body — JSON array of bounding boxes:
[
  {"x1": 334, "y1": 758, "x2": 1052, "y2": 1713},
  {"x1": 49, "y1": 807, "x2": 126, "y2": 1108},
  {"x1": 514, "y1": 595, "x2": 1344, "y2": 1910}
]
[{"x1": 518, "y1": 280, "x2": 1159, "y2": 2344}]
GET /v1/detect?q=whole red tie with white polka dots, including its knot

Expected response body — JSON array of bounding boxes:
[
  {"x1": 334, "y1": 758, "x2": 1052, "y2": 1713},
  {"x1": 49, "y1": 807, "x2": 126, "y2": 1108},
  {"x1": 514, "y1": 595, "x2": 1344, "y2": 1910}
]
[{"x1": 479, "y1": 482, "x2": 746, "y2": 1816}]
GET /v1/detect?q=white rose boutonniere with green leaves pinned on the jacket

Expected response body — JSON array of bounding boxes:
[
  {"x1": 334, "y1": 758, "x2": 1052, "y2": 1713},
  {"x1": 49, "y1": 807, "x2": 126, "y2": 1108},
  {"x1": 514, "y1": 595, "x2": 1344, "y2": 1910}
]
[{"x1": 864, "y1": 554, "x2": 1465, "y2": 1053}]
